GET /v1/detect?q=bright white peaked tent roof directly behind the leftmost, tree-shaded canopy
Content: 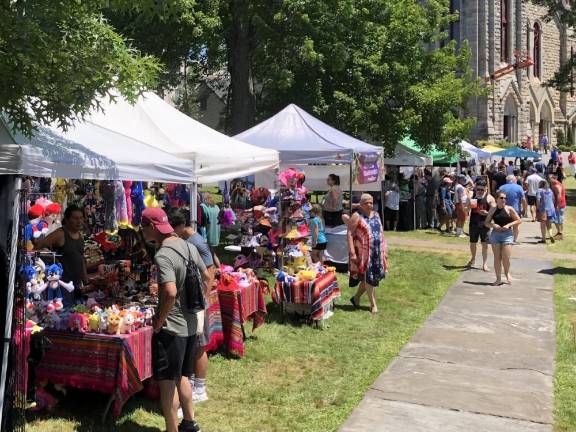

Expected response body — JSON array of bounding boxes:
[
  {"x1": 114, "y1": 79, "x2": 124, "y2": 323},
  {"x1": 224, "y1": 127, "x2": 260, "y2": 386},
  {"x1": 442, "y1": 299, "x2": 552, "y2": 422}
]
[{"x1": 88, "y1": 92, "x2": 278, "y2": 183}]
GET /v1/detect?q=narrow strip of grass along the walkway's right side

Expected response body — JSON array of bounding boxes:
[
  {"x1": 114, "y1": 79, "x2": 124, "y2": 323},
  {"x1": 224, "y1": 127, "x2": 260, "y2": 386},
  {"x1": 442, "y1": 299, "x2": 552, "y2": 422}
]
[{"x1": 554, "y1": 260, "x2": 576, "y2": 432}]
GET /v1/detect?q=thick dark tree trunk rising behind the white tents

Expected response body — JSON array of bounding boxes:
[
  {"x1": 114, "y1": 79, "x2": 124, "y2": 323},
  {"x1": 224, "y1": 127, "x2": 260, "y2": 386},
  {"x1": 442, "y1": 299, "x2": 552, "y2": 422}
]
[{"x1": 228, "y1": 0, "x2": 256, "y2": 135}]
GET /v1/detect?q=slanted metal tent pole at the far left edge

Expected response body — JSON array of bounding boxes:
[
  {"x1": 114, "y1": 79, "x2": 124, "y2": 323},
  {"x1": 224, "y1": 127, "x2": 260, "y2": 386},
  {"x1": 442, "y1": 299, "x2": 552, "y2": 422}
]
[{"x1": 0, "y1": 177, "x2": 22, "y2": 426}]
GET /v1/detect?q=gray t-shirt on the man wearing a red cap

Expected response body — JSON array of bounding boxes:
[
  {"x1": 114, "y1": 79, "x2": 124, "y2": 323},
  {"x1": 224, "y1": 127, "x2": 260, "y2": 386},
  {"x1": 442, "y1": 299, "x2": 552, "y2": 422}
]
[{"x1": 154, "y1": 238, "x2": 206, "y2": 336}]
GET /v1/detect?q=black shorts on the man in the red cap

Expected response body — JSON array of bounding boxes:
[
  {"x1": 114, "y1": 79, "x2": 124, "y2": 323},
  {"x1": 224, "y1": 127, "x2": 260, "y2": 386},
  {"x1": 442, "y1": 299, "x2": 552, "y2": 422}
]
[{"x1": 152, "y1": 330, "x2": 197, "y2": 381}]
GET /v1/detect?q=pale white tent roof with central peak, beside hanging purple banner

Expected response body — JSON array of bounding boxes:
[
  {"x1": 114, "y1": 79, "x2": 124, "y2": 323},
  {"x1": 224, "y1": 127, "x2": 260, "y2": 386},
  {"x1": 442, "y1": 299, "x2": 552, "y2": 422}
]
[{"x1": 235, "y1": 104, "x2": 382, "y2": 165}]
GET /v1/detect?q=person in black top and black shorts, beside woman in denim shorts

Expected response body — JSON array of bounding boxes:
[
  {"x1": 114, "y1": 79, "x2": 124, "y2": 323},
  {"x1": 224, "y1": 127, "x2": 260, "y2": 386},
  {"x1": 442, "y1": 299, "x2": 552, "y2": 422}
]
[{"x1": 467, "y1": 179, "x2": 496, "y2": 271}]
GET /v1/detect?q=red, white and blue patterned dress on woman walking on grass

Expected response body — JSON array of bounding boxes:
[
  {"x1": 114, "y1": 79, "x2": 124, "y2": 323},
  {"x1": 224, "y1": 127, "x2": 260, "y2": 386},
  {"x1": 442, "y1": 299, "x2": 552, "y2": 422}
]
[{"x1": 350, "y1": 212, "x2": 388, "y2": 286}]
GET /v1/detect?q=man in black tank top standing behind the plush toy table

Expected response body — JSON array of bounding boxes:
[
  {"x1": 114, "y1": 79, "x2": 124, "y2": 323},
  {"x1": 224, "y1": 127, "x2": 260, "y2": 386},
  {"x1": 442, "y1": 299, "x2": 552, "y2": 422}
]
[{"x1": 34, "y1": 205, "x2": 88, "y2": 305}]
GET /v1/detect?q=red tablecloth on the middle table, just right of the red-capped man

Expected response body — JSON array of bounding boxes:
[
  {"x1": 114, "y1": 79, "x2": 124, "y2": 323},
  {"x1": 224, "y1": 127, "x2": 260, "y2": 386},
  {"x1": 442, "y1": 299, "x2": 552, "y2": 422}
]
[{"x1": 217, "y1": 280, "x2": 268, "y2": 357}]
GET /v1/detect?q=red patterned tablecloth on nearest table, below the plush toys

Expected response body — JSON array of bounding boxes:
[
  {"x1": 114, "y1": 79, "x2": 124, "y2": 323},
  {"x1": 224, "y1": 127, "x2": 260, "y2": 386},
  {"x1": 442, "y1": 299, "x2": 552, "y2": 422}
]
[{"x1": 36, "y1": 327, "x2": 152, "y2": 416}]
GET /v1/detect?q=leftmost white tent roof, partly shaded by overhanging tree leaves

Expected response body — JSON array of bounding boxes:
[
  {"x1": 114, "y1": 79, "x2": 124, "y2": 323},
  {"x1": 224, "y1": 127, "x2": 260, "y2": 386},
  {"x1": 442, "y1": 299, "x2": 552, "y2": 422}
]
[{"x1": 0, "y1": 117, "x2": 193, "y2": 183}]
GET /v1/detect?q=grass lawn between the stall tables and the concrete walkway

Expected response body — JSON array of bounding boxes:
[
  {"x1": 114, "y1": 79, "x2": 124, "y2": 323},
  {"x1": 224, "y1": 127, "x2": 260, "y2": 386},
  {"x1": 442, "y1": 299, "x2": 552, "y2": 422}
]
[{"x1": 27, "y1": 249, "x2": 466, "y2": 432}]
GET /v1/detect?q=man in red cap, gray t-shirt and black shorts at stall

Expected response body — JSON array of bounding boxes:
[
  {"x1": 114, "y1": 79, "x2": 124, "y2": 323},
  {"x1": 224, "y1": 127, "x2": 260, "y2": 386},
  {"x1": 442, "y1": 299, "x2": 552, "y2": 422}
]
[{"x1": 141, "y1": 208, "x2": 210, "y2": 432}]
